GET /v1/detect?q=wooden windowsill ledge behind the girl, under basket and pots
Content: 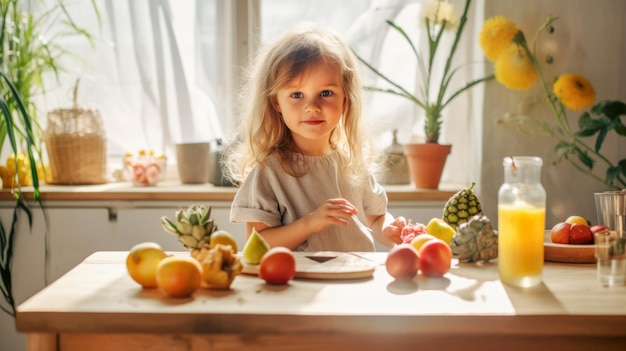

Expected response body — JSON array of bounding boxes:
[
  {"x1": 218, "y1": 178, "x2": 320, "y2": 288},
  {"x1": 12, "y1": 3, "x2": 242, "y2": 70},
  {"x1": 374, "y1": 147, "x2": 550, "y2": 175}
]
[{"x1": 0, "y1": 181, "x2": 457, "y2": 201}]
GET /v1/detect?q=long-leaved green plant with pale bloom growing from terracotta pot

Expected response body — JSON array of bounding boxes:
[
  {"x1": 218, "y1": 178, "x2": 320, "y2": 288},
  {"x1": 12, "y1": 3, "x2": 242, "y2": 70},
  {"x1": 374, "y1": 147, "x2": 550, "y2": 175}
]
[{"x1": 356, "y1": 0, "x2": 494, "y2": 143}]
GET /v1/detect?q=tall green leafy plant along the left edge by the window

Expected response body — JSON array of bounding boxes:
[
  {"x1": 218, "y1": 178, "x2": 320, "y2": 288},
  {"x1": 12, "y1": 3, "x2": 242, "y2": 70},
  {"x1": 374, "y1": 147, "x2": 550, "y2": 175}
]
[{"x1": 0, "y1": 0, "x2": 97, "y2": 316}]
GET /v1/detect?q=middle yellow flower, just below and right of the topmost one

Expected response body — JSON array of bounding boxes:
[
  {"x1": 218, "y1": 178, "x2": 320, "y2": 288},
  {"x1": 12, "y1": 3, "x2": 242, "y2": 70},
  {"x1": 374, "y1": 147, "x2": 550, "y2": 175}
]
[{"x1": 494, "y1": 44, "x2": 538, "y2": 90}]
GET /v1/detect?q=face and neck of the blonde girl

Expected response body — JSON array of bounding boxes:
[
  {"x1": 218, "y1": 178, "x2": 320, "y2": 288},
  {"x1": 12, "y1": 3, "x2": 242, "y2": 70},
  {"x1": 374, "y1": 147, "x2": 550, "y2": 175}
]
[{"x1": 274, "y1": 63, "x2": 346, "y2": 156}]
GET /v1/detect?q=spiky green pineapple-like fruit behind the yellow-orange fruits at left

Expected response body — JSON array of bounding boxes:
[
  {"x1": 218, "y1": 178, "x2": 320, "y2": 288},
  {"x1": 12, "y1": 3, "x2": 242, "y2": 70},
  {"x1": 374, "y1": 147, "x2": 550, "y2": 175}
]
[{"x1": 161, "y1": 205, "x2": 217, "y2": 253}]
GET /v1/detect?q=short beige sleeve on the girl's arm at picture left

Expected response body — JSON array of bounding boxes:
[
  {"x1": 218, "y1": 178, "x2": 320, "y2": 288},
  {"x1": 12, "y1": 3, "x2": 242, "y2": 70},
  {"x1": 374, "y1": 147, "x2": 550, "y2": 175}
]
[{"x1": 230, "y1": 166, "x2": 282, "y2": 227}]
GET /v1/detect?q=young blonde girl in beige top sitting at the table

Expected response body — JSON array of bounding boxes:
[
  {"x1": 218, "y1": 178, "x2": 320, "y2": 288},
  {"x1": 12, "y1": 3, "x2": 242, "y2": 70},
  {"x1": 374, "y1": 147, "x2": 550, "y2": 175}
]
[{"x1": 227, "y1": 24, "x2": 405, "y2": 251}]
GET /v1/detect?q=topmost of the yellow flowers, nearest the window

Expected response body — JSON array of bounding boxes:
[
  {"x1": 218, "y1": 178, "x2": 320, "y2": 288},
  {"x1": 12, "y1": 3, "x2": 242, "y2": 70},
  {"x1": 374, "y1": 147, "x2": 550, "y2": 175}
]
[{"x1": 478, "y1": 16, "x2": 520, "y2": 62}]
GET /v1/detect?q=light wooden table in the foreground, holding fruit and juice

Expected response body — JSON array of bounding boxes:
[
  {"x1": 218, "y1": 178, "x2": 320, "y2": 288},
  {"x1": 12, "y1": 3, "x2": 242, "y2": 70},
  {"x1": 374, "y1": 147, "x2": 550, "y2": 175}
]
[{"x1": 16, "y1": 252, "x2": 626, "y2": 351}]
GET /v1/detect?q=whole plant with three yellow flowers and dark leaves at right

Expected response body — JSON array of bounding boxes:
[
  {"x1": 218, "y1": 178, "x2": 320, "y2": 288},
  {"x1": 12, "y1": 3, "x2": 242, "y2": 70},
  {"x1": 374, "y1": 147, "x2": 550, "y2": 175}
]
[{"x1": 479, "y1": 16, "x2": 626, "y2": 190}]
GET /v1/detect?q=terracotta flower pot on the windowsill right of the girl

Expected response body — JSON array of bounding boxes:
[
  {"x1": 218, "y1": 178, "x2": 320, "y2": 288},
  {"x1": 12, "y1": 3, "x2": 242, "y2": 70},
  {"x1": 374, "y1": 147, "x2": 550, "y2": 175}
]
[{"x1": 404, "y1": 143, "x2": 452, "y2": 189}]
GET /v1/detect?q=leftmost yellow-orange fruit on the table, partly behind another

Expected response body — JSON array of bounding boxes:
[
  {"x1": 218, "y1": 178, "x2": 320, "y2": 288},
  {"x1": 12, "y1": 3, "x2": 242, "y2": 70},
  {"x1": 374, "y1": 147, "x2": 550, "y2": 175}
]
[{"x1": 126, "y1": 242, "x2": 167, "y2": 288}]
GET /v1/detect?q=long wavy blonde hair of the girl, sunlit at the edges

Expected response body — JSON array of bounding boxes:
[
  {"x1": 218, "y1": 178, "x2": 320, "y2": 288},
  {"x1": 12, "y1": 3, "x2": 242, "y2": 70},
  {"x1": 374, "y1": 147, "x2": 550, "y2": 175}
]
[{"x1": 223, "y1": 23, "x2": 381, "y2": 184}]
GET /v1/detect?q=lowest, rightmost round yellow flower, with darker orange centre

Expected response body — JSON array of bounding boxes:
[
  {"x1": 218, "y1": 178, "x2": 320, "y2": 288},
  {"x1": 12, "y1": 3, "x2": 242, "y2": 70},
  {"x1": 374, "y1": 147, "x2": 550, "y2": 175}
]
[{"x1": 552, "y1": 74, "x2": 596, "y2": 110}]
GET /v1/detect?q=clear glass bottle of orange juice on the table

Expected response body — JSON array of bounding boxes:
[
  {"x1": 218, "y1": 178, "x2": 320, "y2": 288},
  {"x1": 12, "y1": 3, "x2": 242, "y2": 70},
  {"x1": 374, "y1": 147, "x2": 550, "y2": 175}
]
[{"x1": 498, "y1": 156, "x2": 546, "y2": 288}]
